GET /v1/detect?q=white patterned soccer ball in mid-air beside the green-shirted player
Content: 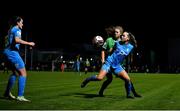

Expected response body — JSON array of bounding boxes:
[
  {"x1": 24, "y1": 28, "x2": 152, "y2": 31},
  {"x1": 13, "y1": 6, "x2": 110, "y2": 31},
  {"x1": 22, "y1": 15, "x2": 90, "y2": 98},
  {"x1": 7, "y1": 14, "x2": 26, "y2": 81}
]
[{"x1": 92, "y1": 35, "x2": 104, "y2": 47}]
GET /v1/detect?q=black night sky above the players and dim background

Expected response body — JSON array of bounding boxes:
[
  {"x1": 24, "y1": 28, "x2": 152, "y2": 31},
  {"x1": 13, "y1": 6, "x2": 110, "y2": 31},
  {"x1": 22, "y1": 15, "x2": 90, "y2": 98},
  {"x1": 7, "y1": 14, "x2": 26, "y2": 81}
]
[{"x1": 0, "y1": 1, "x2": 180, "y2": 67}]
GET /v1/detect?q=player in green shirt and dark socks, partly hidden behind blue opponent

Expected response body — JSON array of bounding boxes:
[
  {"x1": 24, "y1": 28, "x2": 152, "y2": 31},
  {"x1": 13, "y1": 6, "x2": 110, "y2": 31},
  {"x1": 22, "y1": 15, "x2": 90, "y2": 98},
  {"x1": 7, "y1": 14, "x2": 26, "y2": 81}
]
[{"x1": 99, "y1": 26, "x2": 123, "y2": 96}]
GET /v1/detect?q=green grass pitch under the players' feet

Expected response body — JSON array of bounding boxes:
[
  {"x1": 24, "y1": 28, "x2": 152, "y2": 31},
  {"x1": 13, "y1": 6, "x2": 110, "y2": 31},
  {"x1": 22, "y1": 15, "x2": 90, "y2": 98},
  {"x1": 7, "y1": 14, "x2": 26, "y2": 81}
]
[{"x1": 0, "y1": 72, "x2": 180, "y2": 110}]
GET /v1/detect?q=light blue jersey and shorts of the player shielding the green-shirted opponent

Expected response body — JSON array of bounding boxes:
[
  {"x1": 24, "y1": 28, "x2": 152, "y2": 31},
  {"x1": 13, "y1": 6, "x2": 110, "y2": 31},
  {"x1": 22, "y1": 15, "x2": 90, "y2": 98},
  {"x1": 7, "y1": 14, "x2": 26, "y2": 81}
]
[{"x1": 102, "y1": 41, "x2": 134, "y2": 74}]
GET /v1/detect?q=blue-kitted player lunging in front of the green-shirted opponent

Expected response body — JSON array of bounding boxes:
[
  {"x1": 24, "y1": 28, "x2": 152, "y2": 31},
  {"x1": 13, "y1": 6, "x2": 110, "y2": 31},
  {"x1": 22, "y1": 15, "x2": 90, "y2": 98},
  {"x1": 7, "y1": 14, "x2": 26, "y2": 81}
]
[{"x1": 81, "y1": 32, "x2": 141, "y2": 98}]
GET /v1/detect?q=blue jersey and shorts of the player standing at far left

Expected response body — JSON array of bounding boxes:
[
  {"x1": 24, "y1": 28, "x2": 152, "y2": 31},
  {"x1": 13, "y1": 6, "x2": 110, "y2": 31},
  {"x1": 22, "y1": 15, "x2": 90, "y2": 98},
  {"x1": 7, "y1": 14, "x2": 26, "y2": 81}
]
[{"x1": 3, "y1": 26, "x2": 25, "y2": 69}]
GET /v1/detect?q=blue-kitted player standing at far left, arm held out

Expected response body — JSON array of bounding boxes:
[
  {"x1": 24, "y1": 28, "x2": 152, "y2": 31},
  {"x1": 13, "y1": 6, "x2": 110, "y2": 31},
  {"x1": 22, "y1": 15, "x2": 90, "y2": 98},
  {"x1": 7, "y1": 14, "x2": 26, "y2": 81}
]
[{"x1": 3, "y1": 17, "x2": 35, "y2": 102}]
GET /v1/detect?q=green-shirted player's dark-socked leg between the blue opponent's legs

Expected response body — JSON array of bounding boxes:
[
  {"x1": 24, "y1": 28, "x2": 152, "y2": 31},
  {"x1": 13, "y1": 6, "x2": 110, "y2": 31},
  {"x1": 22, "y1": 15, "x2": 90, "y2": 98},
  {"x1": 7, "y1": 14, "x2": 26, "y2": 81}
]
[{"x1": 99, "y1": 73, "x2": 113, "y2": 96}]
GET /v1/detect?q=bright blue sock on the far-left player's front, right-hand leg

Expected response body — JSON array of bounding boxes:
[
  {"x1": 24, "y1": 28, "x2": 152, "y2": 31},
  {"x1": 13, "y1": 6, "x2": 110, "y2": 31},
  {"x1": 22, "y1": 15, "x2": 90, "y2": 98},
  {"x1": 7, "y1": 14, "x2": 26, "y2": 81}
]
[{"x1": 18, "y1": 76, "x2": 26, "y2": 96}]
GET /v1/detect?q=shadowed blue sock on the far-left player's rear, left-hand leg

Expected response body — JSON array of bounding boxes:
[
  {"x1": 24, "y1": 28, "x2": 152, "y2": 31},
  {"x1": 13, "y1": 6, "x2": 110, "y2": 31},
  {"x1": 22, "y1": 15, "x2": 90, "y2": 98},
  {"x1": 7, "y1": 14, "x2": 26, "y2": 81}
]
[{"x1": 5, "y1": 74, "x2": 16, "y2": 94}]
